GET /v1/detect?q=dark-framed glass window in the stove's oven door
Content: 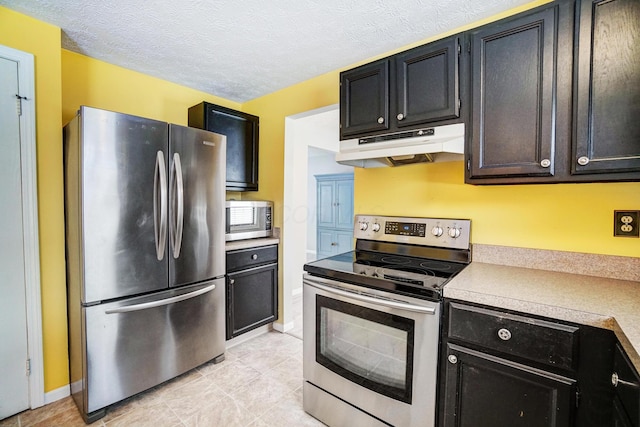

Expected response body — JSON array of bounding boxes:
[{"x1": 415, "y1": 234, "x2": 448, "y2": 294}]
[{"x1": 316, "y1": 295, "x2": 415, "y2": 403}]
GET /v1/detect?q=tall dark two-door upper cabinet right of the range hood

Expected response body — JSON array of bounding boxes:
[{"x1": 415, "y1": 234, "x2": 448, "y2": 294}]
[{"x1": 465, "y1": 0, "x2": 640, "y2": 184}]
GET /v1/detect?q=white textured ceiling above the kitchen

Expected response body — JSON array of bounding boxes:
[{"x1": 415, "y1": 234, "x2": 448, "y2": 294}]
[{"x1": 0, "y1": 0, "x2": 529, "y2": 102}]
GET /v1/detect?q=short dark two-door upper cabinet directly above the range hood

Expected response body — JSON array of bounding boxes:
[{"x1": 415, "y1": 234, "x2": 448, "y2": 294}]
[{"x1": 340, "y1": 36, "x2": 462, "y2": 139}]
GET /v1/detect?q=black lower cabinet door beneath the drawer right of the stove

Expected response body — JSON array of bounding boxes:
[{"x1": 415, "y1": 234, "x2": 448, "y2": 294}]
[{"x1": 442, "y1": 344, "x2": 576, "y2": 427}]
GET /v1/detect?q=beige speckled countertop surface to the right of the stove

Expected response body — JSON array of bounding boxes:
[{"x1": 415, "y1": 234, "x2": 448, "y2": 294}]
[{"x1": 444, "y1": 261, "x2": 640, "y2": 370}]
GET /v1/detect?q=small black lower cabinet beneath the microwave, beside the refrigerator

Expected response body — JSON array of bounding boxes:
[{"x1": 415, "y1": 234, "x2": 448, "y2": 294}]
[{"x1": 227, "y1": 245, "x2": 278, "y2": 340}]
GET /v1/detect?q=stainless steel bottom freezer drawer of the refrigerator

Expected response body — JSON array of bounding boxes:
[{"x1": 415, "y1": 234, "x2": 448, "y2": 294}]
[{"x1": 79, "y1": 279, "x2": 225, "y2": 414}]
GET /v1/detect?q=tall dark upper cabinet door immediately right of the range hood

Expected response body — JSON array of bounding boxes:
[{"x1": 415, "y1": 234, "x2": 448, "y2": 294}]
[{"x1": 469, "y1": 5, "x2": 558, "y2": 178}]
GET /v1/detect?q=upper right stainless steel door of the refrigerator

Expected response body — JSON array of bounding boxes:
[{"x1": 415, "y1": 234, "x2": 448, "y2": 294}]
[{"x1": 168, "y1": 125, "x2": 226, "y2": 286}]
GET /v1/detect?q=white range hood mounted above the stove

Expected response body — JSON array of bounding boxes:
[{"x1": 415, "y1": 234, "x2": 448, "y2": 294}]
[{"x1": 336, "y1": 123, "x2": 464, "y2": 168}]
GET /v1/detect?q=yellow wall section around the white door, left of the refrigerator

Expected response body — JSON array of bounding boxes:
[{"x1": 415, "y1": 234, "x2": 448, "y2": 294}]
[{"x1": 0, "y1": 7, "x2": 69, "y2": 391}]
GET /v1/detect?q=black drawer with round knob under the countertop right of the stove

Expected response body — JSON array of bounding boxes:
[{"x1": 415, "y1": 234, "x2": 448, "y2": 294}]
[{"x1": 448, "y1": 303, "x2": 578, "y2": 370}]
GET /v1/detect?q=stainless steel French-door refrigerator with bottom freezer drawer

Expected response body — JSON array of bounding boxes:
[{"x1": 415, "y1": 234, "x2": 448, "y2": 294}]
[{"x1": 64, "y1": 107, "x2": 226, "y2": 422}]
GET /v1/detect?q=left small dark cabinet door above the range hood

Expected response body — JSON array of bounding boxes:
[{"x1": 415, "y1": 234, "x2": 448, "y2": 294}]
[{"x1": 340, "y1": 59, "x2": 389, "y2": 139}]
